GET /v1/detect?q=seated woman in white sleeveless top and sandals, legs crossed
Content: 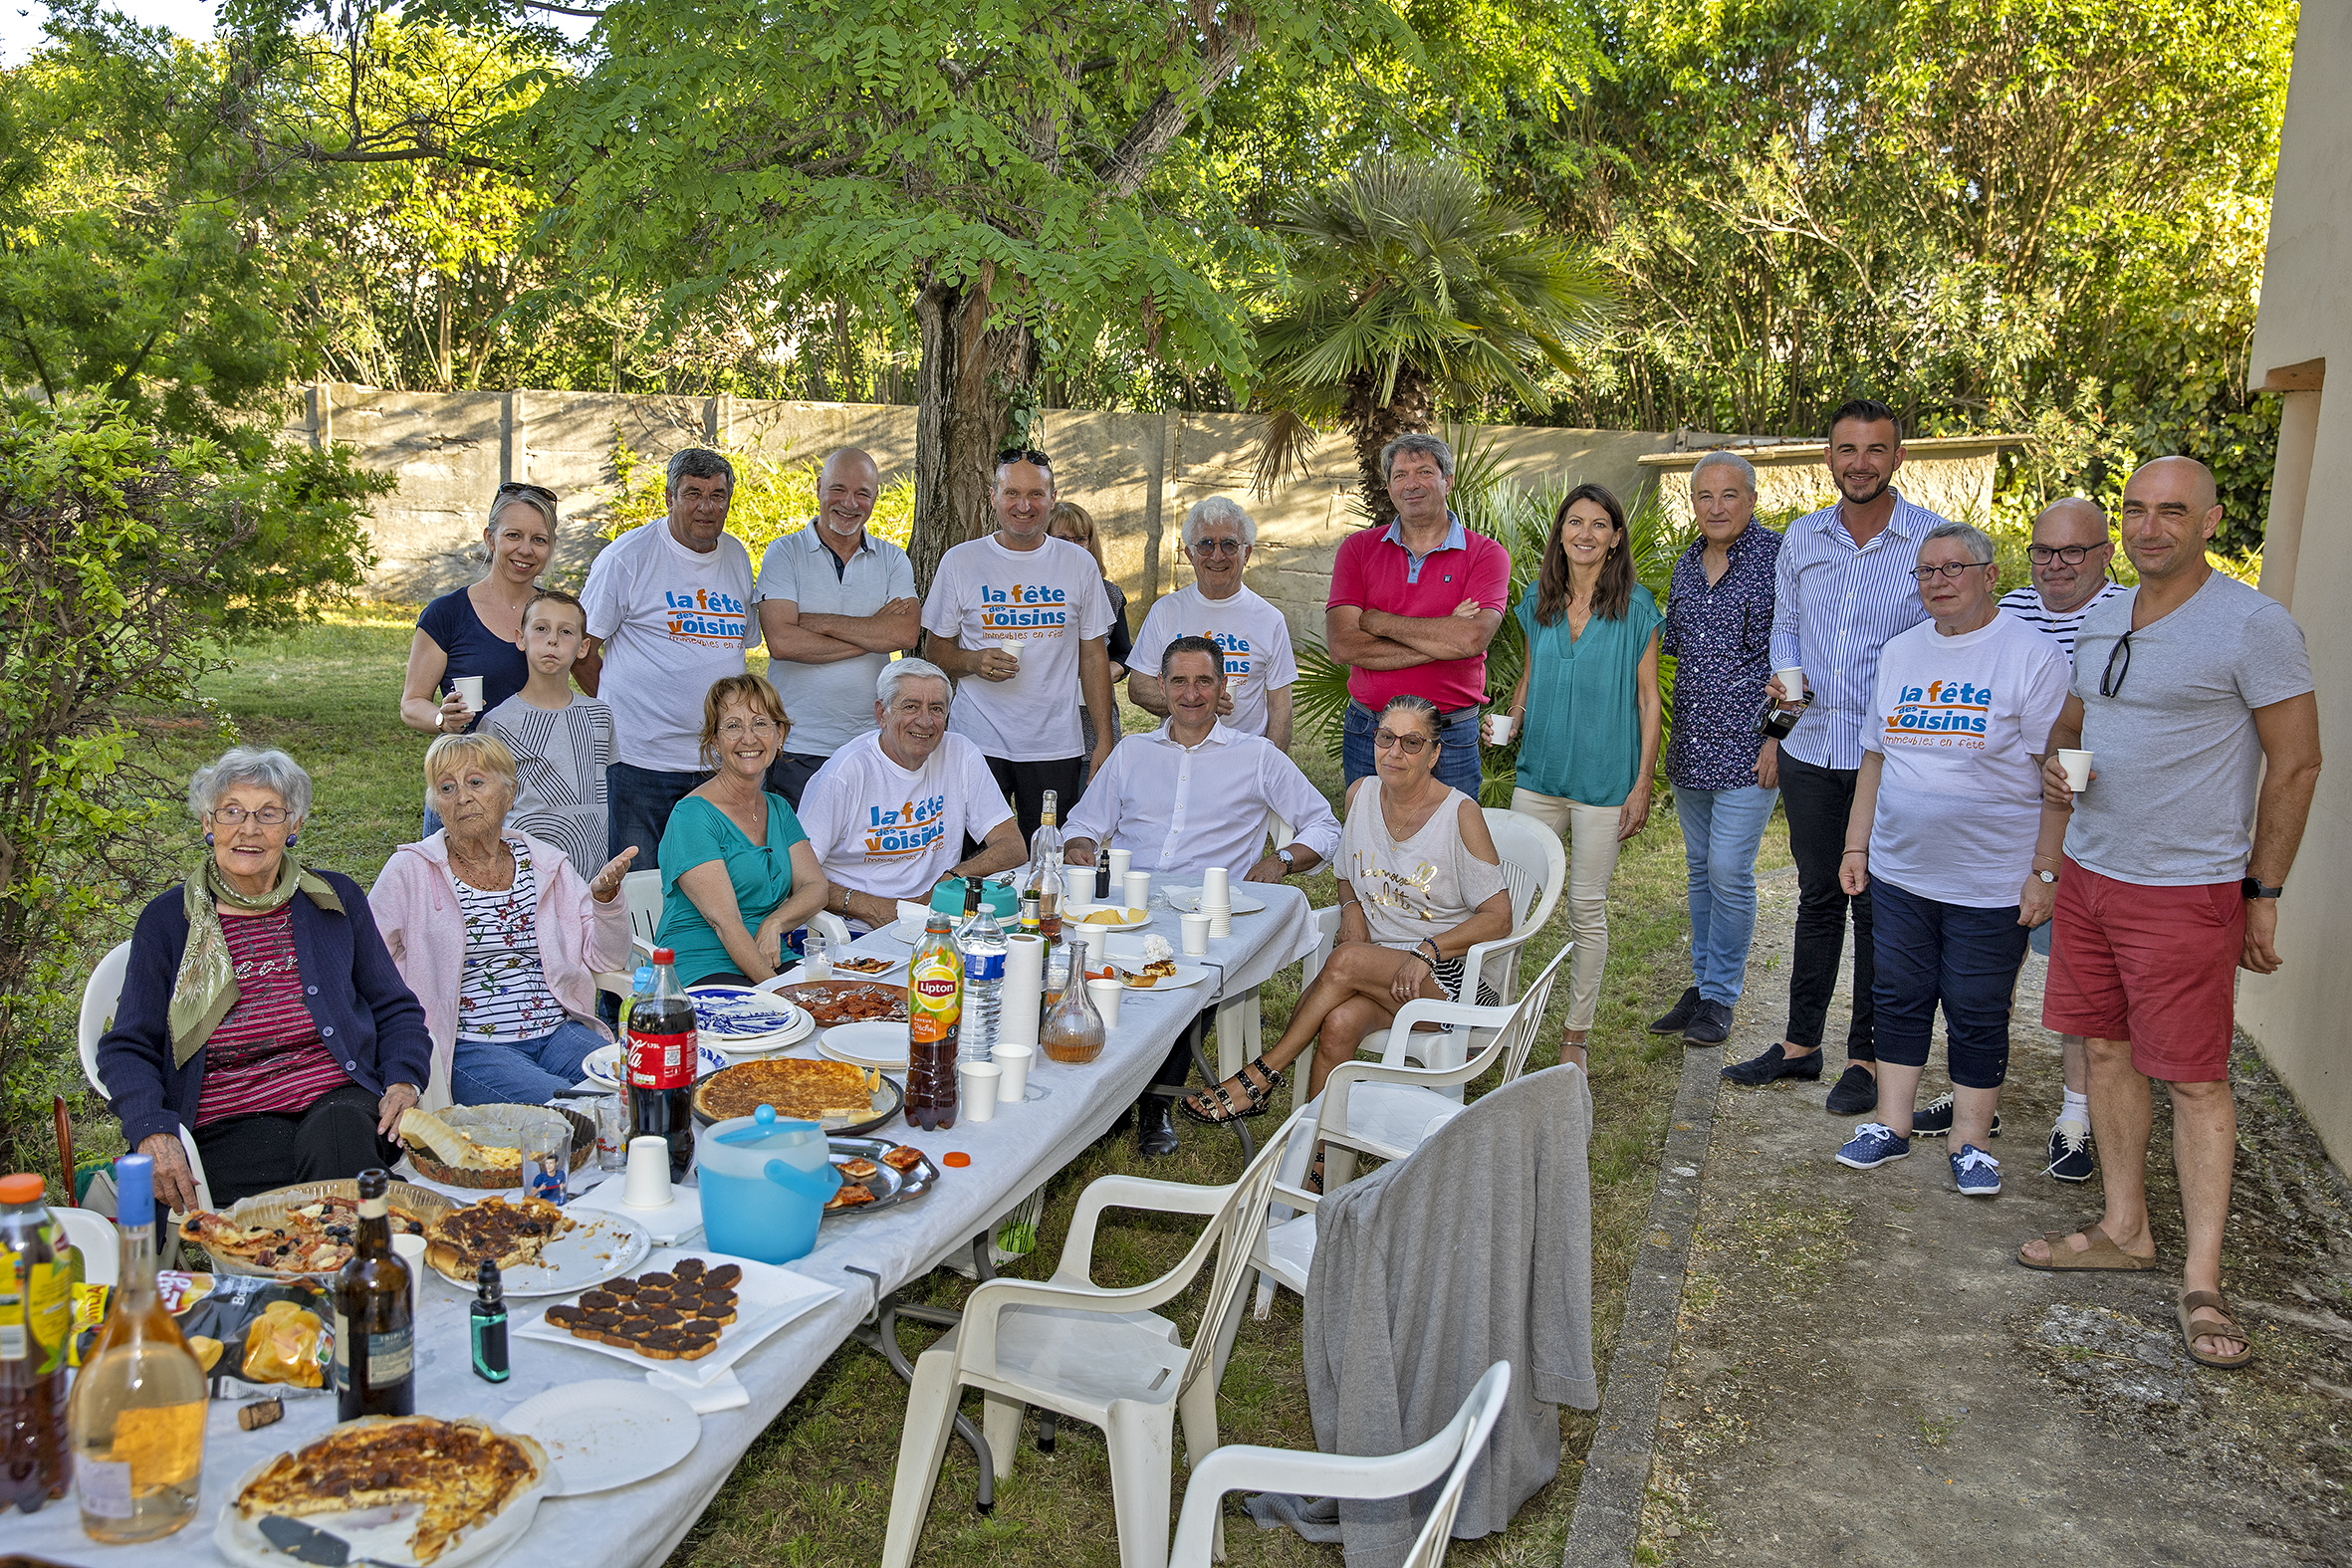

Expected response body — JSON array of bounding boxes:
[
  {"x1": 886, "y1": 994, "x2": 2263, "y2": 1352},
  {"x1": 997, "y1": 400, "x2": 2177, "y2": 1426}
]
[{"x1": 1183, "y1": 696, "x2": 1510, "y2": 1185}]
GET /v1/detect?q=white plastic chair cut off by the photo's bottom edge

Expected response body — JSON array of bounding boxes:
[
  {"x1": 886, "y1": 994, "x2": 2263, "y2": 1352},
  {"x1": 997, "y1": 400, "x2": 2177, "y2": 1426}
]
[{"x1": 1169, "y1": 1361, "x2": 1510, "y2": 1568}]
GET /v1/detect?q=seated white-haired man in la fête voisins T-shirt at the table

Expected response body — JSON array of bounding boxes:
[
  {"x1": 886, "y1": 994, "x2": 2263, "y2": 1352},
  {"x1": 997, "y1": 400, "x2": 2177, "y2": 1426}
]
[{"x1": 800, "y1": 658, "x2": 1023, "y2": 931}]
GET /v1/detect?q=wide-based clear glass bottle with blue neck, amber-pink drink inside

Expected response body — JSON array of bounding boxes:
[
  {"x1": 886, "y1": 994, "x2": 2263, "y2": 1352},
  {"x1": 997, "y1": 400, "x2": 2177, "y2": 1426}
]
[{"x1": 66, "y1": 1154, "x2": 204, "y2": 1544}]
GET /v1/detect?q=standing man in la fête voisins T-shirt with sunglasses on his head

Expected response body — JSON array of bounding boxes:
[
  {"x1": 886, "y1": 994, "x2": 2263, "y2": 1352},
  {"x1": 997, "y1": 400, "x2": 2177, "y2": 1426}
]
[{"x1": 922, "y1": 449, "x2": 1119, "y2": 844}]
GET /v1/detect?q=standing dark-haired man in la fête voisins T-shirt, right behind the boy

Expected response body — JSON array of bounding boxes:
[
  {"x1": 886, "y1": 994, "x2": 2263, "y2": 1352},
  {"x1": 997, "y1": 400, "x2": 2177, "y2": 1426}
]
[{"x1": 574, "y1": 447, "x2": 758, "y2": 872}]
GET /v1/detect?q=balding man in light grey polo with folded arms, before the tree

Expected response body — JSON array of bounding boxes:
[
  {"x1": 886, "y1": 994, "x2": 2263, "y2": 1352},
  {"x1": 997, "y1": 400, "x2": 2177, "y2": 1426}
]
[{"x1": 750, "y1": 447, "x2": 922, "y2": 811}]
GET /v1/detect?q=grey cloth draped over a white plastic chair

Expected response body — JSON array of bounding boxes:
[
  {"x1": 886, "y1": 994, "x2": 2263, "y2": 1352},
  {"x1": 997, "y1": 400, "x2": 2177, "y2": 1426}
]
[{"x1": 1249, "y1": 1067, "x2": 1599, "y2": 1568}]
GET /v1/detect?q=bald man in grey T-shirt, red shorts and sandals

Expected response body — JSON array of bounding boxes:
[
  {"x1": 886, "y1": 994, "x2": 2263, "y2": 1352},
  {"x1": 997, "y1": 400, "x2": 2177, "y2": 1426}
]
[{"x1": 2018, "y1": 458, "x2": 2319, "y2": 1366}]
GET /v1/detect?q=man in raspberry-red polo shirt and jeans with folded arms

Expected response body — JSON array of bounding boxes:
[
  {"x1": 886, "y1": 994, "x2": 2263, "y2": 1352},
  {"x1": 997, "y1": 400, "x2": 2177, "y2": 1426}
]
[{"x1": 1324, "y1": 435, "x2": 1510, "y2": 799}]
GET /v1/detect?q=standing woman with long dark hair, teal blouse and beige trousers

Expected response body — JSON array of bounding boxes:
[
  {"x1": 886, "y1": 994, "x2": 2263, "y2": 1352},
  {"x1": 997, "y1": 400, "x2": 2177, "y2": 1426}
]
[{"x1": 1510, "y1": 484, "x2": 1665, "y2": 1060}]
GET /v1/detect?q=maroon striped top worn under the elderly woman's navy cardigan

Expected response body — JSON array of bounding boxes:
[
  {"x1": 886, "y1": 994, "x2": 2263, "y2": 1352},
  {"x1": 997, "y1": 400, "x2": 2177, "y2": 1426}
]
[{"x1": 195, "y1": 905, "x2": 351, "y2": 1126}]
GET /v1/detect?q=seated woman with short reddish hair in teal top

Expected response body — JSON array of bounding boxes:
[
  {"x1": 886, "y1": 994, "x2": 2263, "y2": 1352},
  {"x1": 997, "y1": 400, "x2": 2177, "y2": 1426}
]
[{"x1": 656, "y1": 675, "x2": 827, "y2": 985}]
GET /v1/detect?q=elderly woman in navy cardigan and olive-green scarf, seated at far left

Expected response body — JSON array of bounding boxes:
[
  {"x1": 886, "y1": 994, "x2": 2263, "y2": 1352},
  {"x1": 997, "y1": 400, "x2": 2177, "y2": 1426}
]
[{"x1": 99, "y1": 746, "x2": 433, "y2": 1213}]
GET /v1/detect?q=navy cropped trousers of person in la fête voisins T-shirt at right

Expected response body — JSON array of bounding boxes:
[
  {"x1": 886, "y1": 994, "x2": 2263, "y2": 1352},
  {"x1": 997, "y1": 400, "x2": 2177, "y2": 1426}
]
[{"x1": 1870, "y1": 877, "x2": 2027, "y2": 1088}]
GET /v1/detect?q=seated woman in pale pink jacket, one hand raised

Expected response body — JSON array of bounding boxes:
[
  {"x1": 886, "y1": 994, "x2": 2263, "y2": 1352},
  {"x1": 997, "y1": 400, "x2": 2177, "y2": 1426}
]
[{"x1": 366, "y1": 734, "x2": 637, "y2": 1105}]
